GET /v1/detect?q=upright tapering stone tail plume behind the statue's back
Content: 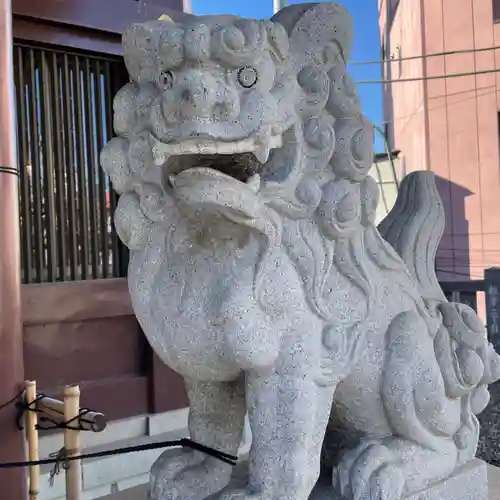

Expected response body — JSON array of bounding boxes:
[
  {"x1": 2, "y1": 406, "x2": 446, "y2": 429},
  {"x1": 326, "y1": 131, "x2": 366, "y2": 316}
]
[{"x1": 378, "y1": 170, "x2": 446, "y2": 302}]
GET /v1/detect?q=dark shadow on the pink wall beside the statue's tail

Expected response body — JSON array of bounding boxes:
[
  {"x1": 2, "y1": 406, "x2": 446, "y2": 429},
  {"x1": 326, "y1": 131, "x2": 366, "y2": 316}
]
[{"x1": 436, "y1": 175, "x2": 474, "y2": 281}]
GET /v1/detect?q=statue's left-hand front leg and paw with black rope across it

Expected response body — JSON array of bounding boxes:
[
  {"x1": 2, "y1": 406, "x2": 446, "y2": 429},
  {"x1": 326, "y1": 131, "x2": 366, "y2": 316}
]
[{"x1": 149, "y1": 378, "x2": 245, "y2": 500}]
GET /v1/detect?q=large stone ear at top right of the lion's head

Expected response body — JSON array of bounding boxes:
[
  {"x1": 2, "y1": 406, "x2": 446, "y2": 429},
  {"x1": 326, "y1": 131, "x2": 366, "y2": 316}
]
[{"x1": 271, "y1": 3, "x2": 354, "y2": 70}]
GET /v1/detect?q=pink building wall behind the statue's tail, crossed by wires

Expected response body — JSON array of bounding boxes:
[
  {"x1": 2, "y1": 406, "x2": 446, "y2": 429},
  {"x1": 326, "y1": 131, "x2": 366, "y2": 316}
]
[{"x1": 379, "y1": 0, "x2": 500, "y2": 286}]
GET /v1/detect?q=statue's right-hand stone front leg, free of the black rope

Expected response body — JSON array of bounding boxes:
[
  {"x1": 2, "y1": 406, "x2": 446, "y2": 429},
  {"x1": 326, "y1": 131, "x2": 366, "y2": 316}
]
[{"x1": 221, "y1": 346, "x2": 334, "y2": 500}]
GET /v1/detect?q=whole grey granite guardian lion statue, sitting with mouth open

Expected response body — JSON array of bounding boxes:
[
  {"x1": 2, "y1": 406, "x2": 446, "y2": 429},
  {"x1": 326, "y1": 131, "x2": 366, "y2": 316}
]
[{"x1": 101, "y1": 3, "x2": 500, "y2": 500}]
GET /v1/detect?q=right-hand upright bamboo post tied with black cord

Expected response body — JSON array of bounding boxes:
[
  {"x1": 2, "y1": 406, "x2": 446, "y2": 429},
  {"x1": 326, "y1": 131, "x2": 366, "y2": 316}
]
[{"x1": 64, "y1": 386, "x2": 82, "y2": 500}]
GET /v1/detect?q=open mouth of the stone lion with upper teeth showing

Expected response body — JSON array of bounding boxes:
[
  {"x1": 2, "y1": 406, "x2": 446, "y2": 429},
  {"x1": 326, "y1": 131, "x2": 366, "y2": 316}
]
[{"x1": 151, "y1": 136, "x2": 282, "y2": 184}]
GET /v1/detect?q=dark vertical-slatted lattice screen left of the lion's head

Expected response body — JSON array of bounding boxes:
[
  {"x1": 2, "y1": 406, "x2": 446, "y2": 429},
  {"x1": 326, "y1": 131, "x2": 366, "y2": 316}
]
[{"x1": 14, "y1": 43, "x2": 127, "y2": 283}]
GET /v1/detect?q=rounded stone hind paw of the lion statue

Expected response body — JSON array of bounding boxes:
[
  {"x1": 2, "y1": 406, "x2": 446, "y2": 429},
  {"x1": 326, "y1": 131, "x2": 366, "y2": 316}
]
[{"x1": 333, "y1": 442, "x2": 405, "y2": 500}]
